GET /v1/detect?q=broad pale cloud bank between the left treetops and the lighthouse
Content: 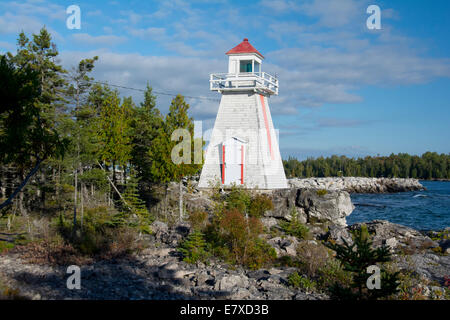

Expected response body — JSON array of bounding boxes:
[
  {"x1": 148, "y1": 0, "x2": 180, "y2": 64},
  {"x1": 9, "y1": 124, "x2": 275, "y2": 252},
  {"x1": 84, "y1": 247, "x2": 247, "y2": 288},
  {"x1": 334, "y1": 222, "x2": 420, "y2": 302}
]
[{"x1": 61, "y1": 50, "x2": 220, "y2": 121}]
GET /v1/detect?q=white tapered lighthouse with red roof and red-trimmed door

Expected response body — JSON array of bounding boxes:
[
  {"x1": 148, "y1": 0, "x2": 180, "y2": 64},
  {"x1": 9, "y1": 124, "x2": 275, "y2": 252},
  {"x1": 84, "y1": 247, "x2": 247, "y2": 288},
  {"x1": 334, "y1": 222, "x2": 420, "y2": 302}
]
[{"x1": 198, "y1": 39, "x2": 288, "y2": 189}]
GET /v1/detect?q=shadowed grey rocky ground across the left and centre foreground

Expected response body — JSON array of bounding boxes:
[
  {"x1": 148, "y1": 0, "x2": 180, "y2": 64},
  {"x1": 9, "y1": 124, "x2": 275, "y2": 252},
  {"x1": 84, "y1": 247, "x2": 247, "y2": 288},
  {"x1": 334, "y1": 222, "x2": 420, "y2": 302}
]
[{"x1": 0, "y1": 222, "x2": 327, "y2": 300}]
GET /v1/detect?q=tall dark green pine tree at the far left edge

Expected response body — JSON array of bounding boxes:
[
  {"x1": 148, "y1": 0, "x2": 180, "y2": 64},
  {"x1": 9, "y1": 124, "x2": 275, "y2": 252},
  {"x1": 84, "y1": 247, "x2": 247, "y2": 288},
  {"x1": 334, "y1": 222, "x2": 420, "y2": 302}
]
[{"x1": 0, "y1": 28, "x2": 68, "y2": 213}]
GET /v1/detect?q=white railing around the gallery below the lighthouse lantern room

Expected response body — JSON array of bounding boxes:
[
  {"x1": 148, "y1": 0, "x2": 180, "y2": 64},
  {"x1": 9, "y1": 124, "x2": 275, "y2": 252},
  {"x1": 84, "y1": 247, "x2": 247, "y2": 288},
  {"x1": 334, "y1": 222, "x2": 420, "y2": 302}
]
[{"x1": 209, "y1": 72, "x2": 278, "y2": 95}]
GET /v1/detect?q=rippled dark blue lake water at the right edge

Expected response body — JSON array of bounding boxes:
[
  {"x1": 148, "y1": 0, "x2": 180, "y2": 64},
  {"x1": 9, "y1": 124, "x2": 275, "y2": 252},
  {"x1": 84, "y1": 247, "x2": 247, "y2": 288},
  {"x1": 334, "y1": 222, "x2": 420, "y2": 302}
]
[{"x1": 347, "y1": 181, "x2": 450, "y2": 230}]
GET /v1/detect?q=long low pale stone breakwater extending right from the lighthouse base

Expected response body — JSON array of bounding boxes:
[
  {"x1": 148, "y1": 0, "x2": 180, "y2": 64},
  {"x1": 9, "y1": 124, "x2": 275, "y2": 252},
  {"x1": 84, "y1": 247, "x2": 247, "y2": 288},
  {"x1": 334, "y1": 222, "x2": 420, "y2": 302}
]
[{"x1": 289, "y1": 177, "x2": 425, "y2": 193}]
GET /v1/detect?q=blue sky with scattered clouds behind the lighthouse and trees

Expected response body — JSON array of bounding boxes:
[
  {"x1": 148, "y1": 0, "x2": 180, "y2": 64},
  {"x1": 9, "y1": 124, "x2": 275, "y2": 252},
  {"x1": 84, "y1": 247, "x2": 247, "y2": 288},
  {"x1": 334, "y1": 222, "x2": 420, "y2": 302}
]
[{"x1": 0, "y1": 0, "x2": 450, "y2": 159}]
